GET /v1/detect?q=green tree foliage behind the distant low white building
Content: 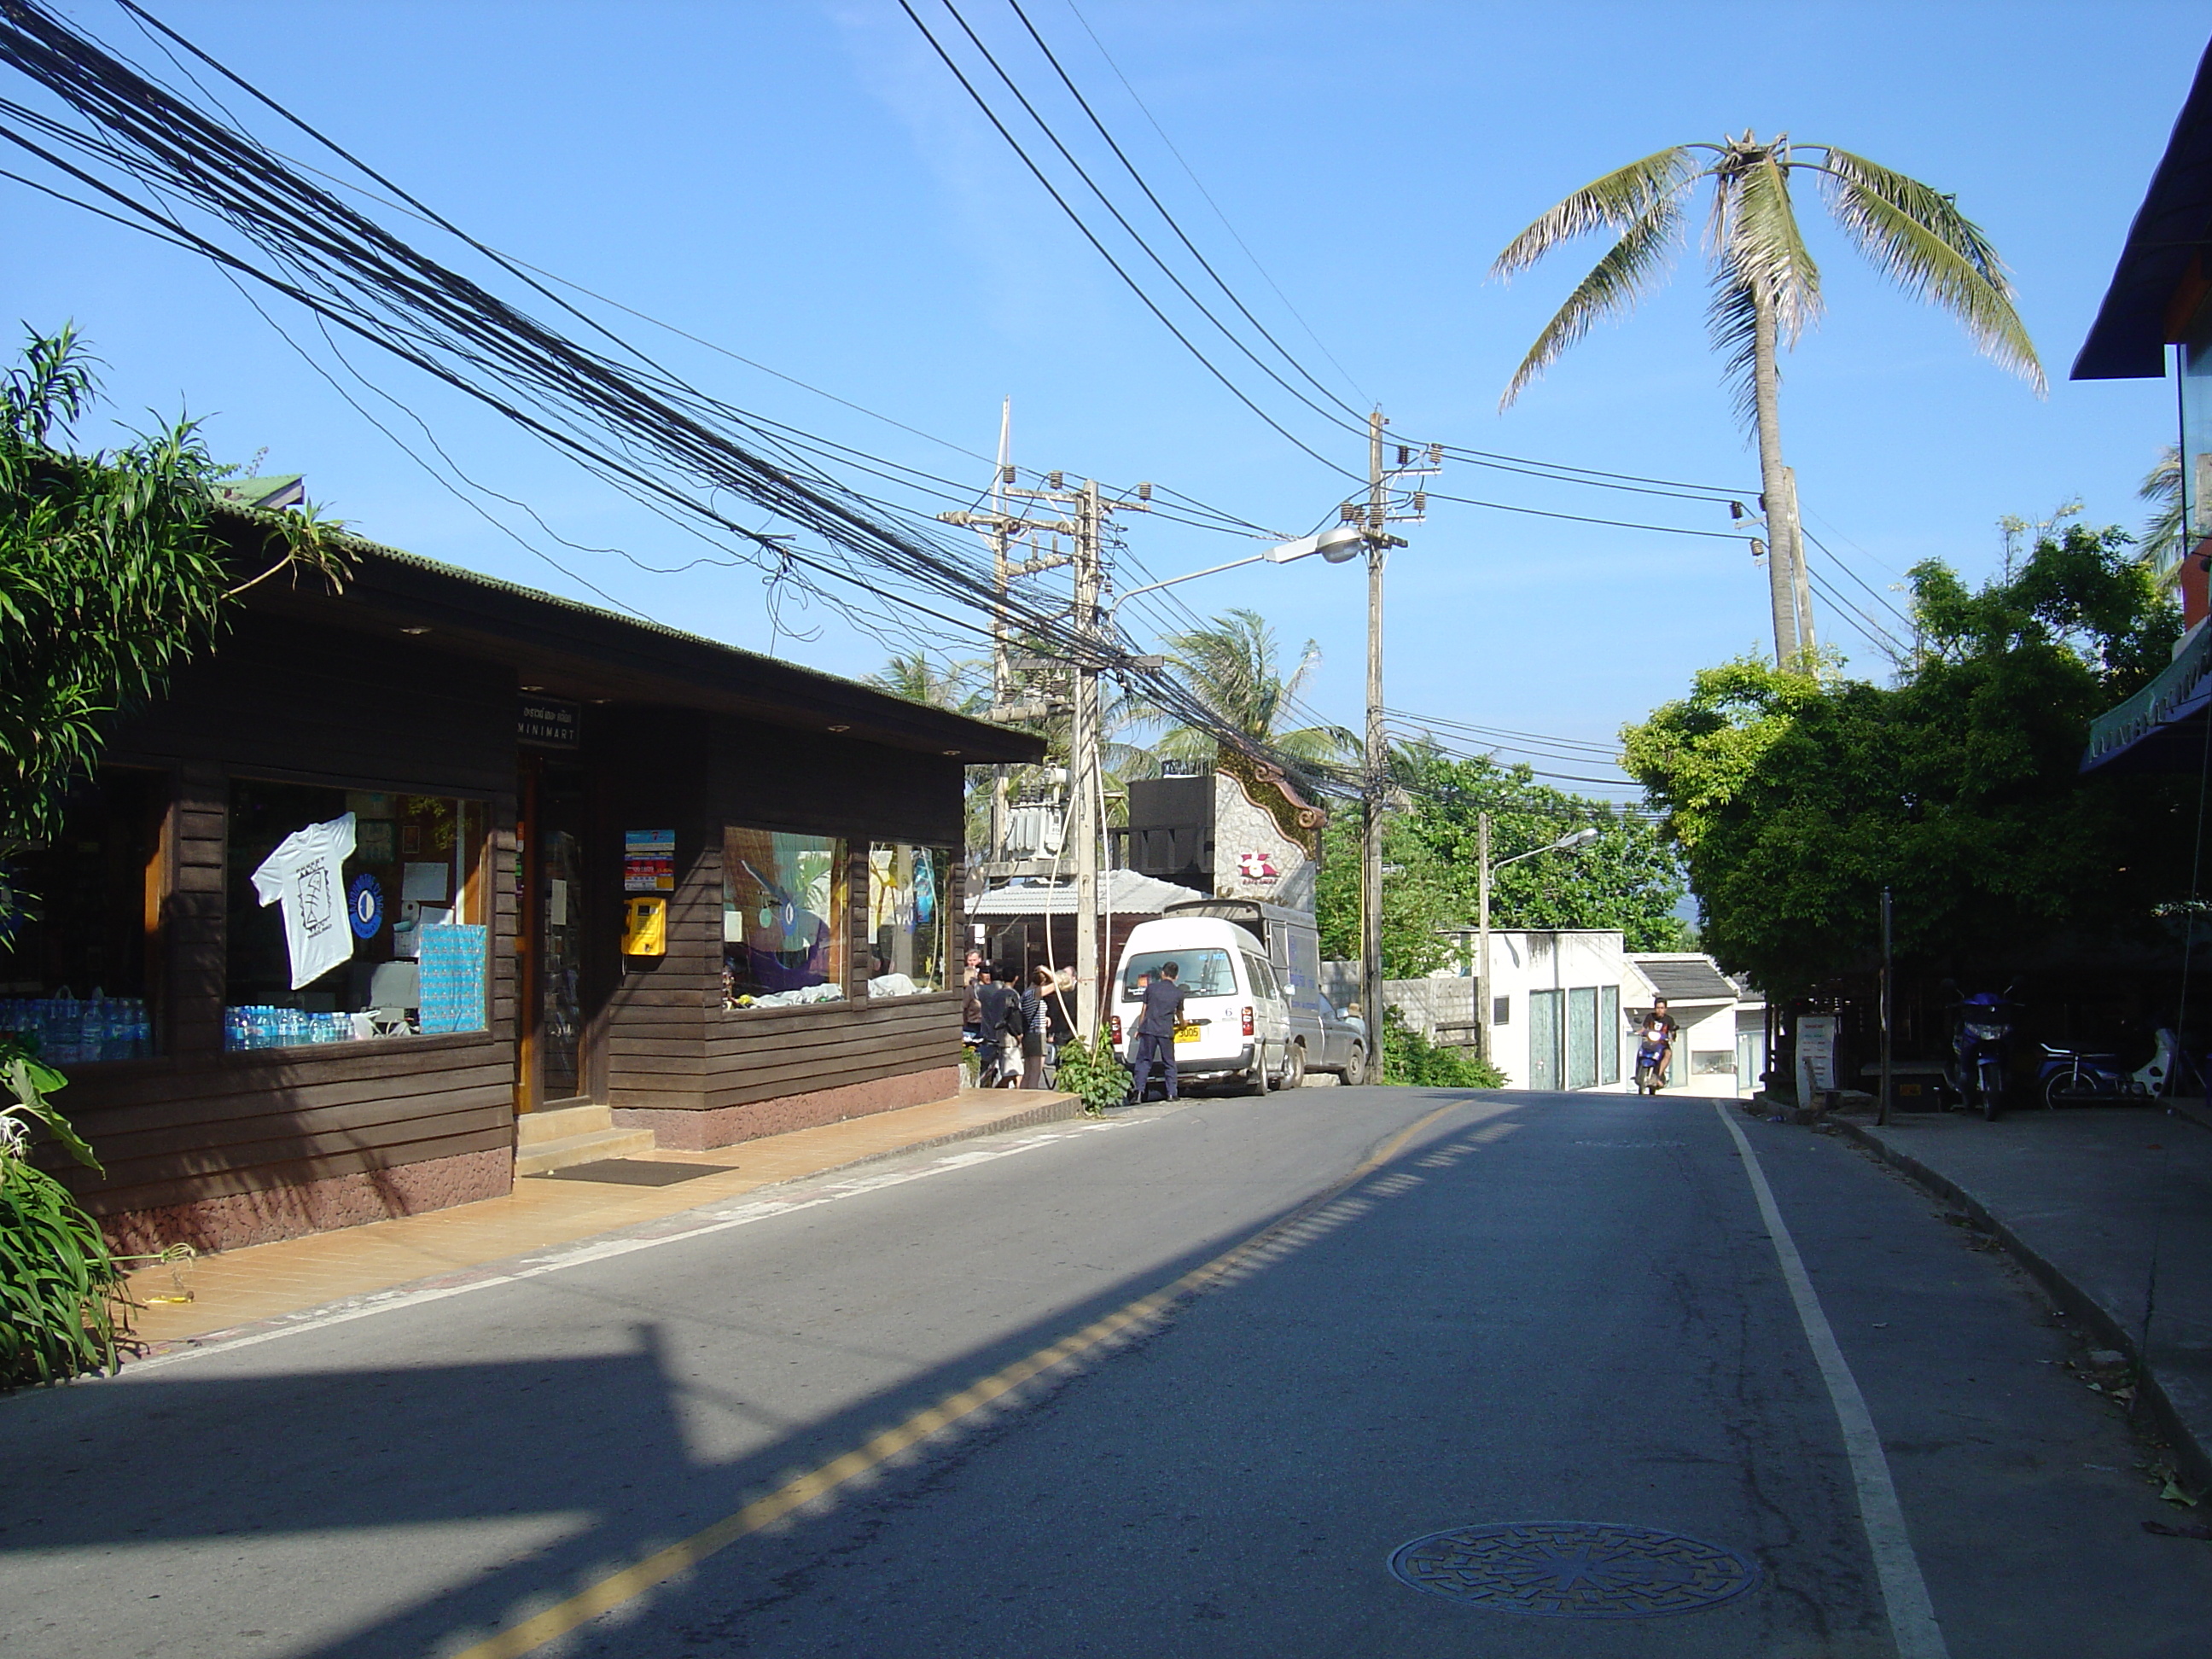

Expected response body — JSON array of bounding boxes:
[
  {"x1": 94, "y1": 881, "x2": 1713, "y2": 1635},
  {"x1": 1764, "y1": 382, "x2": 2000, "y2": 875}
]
[{"x1": 1318, "y1": 743, "x2": 1688, "y2": 980}]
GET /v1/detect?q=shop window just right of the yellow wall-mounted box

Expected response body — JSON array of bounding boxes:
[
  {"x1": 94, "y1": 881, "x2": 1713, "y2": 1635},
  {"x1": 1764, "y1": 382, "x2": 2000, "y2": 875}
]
[{"x1": 721, "y1": 825, "x2": 852, "y2": 1009}]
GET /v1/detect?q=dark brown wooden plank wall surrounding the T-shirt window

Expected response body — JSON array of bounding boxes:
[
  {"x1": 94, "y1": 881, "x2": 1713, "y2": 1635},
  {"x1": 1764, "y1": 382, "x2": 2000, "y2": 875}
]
[{"x1": 42, "y1": 615, "x2": 515, "y2": 1214}]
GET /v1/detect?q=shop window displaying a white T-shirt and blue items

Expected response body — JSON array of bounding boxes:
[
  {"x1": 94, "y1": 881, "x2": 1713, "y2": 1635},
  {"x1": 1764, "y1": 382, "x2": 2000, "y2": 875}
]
[{"x1": 224, "y1": 778, "x2": 489, "y2": 1049}]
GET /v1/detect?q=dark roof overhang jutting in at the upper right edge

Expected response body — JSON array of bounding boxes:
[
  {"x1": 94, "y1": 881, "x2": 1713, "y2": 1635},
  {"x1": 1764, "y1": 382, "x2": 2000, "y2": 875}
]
[{"x1": 2070, "y1": 36, "x2": 2212, "y2": 381}]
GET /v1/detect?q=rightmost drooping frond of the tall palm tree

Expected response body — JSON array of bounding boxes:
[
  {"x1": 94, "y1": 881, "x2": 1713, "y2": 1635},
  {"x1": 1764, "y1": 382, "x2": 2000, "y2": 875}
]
[{"x1": 1820, "y1": 148, "x2": 2048, "y2": 396}]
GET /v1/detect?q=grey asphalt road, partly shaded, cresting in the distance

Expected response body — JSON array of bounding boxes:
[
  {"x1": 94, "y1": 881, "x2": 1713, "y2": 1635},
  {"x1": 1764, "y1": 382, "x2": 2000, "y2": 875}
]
[{"x1": 0, "y1": 1088, "x2": 2212, "y2": 1659}]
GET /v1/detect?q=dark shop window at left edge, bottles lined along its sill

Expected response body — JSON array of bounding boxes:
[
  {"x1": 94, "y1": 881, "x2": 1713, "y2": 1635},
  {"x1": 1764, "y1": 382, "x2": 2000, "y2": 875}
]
[{"x1": 0, "y1": 767, "x2": 168, "y2": 1066}]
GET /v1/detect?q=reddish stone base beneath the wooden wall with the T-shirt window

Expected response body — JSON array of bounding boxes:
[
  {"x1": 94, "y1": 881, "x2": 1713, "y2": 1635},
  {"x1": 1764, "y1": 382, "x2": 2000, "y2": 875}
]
[{"x1": 100, "y1": 1148, "x2": 515, "y2": 1254}]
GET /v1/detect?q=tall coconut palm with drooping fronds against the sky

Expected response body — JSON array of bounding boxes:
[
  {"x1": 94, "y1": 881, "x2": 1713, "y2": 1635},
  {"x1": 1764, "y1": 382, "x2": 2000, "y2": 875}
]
[{"x1": 1491, "y1": 131, "x2": 2044, "y2": 664}]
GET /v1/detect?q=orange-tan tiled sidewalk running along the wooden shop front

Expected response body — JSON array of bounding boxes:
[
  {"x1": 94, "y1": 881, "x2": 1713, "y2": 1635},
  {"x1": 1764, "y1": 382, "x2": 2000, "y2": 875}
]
[{"x1": 131, "y1": 1088, "x2": 1081, "y2": 1348}]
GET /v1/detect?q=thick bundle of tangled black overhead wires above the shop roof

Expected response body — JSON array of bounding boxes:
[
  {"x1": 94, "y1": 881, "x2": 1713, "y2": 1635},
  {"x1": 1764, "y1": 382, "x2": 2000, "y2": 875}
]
[{"x1": 0, "y1": 0, "x2": 1274, "y2": 778}]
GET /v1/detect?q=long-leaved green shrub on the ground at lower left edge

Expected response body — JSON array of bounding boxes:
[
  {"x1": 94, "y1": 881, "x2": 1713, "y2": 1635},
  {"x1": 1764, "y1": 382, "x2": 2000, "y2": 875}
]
[{"x1": 0, "y1": 1038, "x2": 124, "y2": 1389}]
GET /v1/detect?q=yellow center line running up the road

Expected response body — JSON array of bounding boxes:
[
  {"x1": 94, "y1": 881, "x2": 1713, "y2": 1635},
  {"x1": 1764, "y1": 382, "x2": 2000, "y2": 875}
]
[{"x1": 453, "y1": 1102, "x2": 1466, "y2": 1659}]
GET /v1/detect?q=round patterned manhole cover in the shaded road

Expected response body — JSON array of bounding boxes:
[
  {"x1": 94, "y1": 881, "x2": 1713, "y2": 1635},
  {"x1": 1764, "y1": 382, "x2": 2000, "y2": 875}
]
[{"x1": 1389, "y1": 1522, "x2": 1759, "y2": 1619}]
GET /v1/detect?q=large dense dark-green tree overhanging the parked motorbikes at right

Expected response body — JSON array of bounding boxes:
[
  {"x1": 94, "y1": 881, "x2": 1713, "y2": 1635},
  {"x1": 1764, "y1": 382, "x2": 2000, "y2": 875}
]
[{"x1": 1624, "y1": 524, "x2": 2194, "y2": 995}]
